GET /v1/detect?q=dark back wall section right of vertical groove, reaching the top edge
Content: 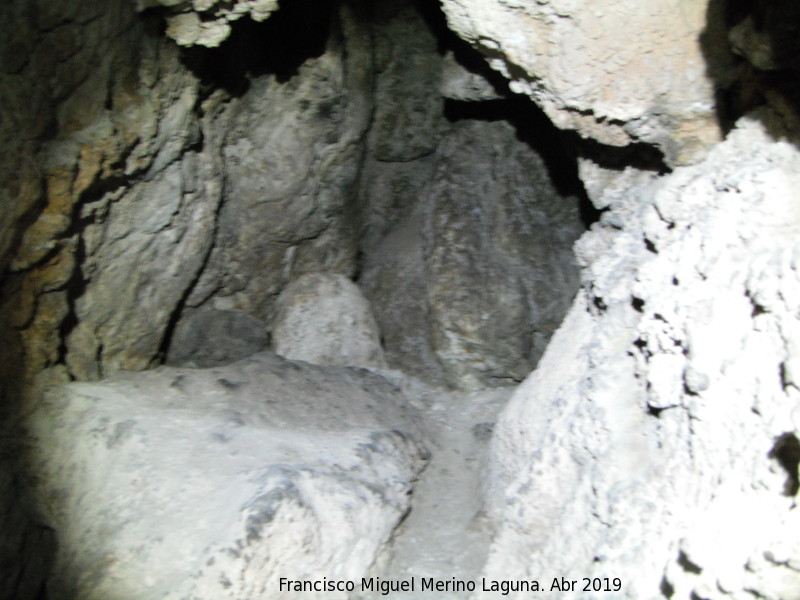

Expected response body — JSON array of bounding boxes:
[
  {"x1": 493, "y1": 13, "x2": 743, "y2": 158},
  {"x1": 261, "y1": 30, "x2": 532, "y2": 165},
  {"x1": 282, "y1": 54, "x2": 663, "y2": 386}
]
[{"x1": 359, "y1": 2, "x2": 583, "y2": 388}]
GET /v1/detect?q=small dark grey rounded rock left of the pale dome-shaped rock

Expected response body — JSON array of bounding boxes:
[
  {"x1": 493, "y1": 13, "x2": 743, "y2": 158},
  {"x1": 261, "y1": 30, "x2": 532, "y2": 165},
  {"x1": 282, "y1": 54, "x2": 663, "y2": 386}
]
[{"x1": 166, "y1": 310, "x2": 269, "y2": 368}]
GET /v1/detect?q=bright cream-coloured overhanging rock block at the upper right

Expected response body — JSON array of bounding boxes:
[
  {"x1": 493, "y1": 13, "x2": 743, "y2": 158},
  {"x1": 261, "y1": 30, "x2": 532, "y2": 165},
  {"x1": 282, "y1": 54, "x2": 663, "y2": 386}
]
[{"x1": 442, "y1": 0, "x2": 725, "y2": 164}]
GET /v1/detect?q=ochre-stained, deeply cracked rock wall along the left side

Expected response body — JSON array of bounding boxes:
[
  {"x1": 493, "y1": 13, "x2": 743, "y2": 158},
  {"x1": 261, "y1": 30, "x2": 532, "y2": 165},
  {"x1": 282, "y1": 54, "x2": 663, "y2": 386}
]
[{"x1": 0, "y1": 2, "x2": 212, "y2": 384}]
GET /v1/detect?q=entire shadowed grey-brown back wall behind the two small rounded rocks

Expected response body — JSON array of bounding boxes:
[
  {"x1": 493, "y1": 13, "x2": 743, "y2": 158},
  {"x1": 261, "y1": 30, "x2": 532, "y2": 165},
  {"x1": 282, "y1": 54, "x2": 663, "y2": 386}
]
[{"x1": 3, "y1": 2, "x2": 581, "y2": 387}]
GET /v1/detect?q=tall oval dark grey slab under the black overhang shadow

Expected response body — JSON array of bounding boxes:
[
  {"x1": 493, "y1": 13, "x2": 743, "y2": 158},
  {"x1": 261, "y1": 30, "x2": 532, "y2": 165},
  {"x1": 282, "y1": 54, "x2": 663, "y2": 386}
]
[{"x1": 424, "y1": 121, "x2": 582, "y2": 388}]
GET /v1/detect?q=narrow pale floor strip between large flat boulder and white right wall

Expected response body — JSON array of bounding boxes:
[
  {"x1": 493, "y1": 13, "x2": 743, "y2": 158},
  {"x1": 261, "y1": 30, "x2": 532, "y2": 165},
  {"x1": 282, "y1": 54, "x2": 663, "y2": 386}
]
[{"x1": 362, "y1": 388, "x2": 514, "y2": 600}]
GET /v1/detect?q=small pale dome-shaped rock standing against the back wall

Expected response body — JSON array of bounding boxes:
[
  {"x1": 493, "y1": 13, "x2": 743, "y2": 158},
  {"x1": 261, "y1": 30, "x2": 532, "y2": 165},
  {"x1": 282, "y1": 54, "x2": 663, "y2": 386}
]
[{"x1": 272, "y1": 273, "x2": 386, "y2": 368}]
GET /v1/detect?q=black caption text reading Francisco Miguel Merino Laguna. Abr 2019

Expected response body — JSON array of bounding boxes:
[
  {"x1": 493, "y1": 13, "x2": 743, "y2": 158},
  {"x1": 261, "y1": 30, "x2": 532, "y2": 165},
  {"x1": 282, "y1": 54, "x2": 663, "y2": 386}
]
[{"x1": 279, "y1": 577, "x2": 622, "y2": 596}]
